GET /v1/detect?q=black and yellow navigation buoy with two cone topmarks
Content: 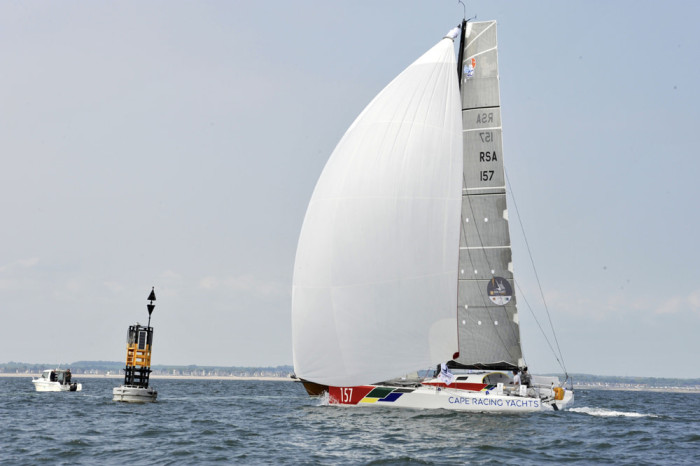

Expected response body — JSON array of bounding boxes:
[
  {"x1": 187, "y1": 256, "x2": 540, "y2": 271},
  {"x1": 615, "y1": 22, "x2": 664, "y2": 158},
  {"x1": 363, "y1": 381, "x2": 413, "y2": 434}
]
[{"x1": 112, "y1": 288, "x2": 158, "y2": 403}]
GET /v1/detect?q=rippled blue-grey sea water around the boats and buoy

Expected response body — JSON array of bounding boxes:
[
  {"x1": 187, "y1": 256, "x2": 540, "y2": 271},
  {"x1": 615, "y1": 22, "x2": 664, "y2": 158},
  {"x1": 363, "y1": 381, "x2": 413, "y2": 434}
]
[{"x1": 0, "y1": 375, "x2": 700, "y2": 465}]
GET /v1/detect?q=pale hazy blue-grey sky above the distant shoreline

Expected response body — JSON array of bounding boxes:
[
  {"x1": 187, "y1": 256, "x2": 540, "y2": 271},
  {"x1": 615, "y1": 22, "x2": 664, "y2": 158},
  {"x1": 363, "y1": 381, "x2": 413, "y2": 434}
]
[{"x1": 0, "y1": 0, "x2": 700, "y2": 377}]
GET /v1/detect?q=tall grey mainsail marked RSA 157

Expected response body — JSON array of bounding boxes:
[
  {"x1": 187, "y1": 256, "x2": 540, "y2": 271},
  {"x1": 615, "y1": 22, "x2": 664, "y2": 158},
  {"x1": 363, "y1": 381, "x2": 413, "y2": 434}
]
[{"x1": 450, "y1": 21, "x2": 523, "y2": 370}]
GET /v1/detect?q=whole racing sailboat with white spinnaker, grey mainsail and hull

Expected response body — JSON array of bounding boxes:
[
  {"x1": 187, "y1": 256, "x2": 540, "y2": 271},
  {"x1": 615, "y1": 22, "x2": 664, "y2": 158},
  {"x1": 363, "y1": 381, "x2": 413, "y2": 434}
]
[{"x1": 292, "y1": 20, "x2": 574, "y2": 412}]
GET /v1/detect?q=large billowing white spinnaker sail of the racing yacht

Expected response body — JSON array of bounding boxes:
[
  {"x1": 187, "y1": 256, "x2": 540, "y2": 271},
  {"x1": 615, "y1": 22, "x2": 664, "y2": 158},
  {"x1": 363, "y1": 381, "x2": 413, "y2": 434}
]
[{"x1": 292, "y1": 39, "x2": 462, "y2": 386}]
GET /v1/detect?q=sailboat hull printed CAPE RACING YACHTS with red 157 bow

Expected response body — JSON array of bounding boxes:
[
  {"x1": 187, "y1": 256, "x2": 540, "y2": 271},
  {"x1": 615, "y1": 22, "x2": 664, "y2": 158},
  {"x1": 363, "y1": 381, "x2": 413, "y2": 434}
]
[{"x1": 328, "y1": 385, "x2": 574, "y2": 413}]
